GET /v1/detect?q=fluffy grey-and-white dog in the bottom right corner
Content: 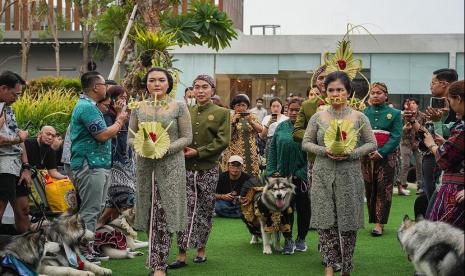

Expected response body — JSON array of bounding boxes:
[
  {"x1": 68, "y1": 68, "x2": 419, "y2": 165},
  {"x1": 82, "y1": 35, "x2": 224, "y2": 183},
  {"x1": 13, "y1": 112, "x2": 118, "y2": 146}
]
[{"x1": 397, "y1": 215, "x2": 465, "y2": 276}]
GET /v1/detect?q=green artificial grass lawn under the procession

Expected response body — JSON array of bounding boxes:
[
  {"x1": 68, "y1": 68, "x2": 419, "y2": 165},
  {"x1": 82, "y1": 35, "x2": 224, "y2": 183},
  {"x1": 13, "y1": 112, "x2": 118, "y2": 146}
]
[{"x1": 103, "y1": 190, "x2": 416, "y2": 276}]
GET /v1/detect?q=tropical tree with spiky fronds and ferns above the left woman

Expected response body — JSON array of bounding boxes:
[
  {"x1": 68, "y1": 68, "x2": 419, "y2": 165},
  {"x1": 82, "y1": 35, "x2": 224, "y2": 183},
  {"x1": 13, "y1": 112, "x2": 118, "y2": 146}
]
[{"x1": 96, "y1": 0, "x2": 237, "y2": 93}]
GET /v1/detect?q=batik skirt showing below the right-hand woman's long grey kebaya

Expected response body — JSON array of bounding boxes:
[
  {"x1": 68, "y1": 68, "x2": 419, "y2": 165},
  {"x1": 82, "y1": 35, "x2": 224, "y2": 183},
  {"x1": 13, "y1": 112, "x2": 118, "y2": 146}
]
[{"x1": 318, "y1": 226, "x2": 357, "y2": 273}]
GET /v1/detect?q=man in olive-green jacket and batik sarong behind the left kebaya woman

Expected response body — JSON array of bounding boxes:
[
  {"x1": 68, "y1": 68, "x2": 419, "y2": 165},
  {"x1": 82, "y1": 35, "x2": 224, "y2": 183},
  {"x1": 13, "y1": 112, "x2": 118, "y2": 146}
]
[{"x1": 169, "y1": 75, "x2": 231, "y2": 269}]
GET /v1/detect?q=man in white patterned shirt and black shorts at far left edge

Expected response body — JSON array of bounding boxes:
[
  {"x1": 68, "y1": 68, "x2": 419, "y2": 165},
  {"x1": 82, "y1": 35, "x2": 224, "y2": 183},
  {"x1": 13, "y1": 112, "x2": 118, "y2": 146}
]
[{"x1": 0, "y1": 71, "x2": 31, "y2": 233}]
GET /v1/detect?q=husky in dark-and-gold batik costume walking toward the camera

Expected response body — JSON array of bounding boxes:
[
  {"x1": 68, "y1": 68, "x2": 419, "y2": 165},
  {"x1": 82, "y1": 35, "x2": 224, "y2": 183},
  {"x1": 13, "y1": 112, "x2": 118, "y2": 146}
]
[{"x1": 242, "y1": 177, "x2": 295, "y2": 255}]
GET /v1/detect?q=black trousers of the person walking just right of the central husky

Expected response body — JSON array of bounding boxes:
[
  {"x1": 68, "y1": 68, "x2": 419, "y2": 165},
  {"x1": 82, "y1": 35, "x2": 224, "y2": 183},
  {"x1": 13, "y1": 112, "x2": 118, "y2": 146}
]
[{"x1": 283, "y1": 177, "x2": 311, "y2": 240}]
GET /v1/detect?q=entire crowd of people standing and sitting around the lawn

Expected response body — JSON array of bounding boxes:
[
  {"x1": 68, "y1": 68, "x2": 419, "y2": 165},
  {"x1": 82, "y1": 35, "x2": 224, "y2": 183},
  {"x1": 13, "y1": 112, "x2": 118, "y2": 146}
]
[{"x1": 0, "y1": 65, "x2": 465, "y2": 275}]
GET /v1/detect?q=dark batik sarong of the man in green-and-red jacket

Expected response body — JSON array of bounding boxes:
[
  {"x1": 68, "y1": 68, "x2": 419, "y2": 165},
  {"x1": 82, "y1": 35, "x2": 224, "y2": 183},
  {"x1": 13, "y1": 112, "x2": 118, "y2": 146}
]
[{"x1": 362, "y1": 149, "x2": 399, "y2": 224}]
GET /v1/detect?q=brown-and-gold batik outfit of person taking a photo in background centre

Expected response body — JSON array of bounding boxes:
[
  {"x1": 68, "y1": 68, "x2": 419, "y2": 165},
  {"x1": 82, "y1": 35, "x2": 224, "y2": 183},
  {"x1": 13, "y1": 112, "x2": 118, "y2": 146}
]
[{"x1": 221, "y1": 113, "x2": 260, "y2": 176}]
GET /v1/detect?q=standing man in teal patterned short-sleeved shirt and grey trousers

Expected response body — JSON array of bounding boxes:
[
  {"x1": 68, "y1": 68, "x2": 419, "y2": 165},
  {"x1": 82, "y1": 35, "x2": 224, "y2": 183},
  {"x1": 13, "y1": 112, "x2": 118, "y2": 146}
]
[{"x1": 70, "y1": 72, "x2": 128, "y2": 232}]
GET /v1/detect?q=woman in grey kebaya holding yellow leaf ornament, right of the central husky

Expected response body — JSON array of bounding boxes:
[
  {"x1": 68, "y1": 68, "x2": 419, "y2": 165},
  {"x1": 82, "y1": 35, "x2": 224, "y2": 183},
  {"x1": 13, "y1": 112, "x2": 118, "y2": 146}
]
[{"x1": 302, "y1": 71, "x2": 376, "y2": 275}]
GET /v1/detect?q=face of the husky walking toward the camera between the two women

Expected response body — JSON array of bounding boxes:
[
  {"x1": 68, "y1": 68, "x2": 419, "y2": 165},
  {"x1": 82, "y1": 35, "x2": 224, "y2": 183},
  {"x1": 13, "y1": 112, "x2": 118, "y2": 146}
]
[{"x1": 262, "y1": 177, "x2": 295, "y2": 211}]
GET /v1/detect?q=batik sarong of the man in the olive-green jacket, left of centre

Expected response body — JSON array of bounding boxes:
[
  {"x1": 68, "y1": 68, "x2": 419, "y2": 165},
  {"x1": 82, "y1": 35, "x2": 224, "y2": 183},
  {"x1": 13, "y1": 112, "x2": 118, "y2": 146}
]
[{"x1": 178, "y1": 167, "x2": 219, "y2": 250}]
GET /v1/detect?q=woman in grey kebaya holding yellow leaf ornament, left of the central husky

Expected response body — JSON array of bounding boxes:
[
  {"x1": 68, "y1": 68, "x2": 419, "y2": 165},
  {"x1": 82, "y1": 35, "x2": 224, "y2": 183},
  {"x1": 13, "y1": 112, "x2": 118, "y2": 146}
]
[{"x1": 129, "y1": 68, "x2": 192, "y2": 275}]
